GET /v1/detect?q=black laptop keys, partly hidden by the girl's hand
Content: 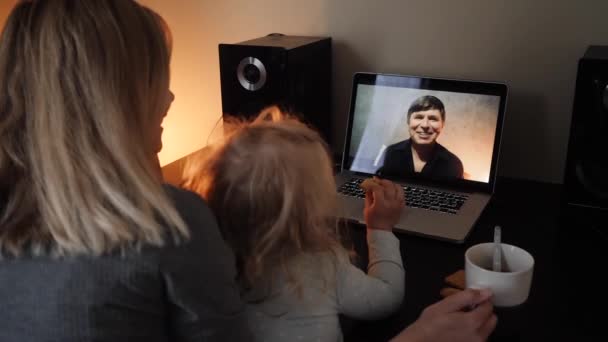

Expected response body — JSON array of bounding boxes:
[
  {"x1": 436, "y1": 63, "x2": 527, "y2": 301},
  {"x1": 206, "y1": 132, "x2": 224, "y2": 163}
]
[{"x1": 338, "y1": 178, "x2": 468, "y2": 214}]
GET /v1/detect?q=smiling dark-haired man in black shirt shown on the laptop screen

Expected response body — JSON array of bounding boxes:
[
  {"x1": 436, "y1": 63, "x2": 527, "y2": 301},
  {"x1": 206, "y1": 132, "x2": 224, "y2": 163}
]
[{"x1": 377, "y1": 95, "x2": 463, "y2": 180}]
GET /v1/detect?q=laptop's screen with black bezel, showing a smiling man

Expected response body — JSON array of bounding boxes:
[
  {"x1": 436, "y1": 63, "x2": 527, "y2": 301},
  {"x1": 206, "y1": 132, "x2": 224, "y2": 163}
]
[{"x1": 343, "y1": 73, "x2": 507, "y2": 191}]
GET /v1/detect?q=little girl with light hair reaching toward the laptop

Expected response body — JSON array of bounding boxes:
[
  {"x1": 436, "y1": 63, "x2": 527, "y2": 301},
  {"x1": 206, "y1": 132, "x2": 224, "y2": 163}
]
[{"x1": 186, "y1": 116, "x2": 405, "y2": 342}]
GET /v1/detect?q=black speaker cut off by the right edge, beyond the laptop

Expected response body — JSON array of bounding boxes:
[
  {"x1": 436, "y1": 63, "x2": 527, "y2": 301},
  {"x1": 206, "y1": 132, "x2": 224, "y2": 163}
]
[{"x1": 564, "y1": 46, "x2": 608, "y2": 212}]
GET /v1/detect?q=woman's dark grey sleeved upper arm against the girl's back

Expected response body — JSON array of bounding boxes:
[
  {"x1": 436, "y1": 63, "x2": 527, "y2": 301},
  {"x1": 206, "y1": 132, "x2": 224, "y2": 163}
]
[{"x1": 160, "y1": 189, "x2": 251, "y2": 342}]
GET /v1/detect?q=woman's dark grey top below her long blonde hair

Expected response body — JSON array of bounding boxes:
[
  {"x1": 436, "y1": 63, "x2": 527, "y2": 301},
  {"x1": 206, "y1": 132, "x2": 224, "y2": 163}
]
[{"x1": 0, "y1": 188, "x2": 250, "y2": 342}]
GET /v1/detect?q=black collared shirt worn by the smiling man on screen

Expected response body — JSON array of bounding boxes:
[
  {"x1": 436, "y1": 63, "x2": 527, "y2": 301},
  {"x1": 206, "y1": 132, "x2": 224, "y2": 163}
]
[{"x1": 377, "y1": 139, "x2": 463, "y2": 180}]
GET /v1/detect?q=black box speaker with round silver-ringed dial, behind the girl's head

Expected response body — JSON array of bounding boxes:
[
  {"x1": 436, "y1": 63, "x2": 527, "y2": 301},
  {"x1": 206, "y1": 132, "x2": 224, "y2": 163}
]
[{"x1": 219, "y1": 34, "x2": 331, "y2": 142}]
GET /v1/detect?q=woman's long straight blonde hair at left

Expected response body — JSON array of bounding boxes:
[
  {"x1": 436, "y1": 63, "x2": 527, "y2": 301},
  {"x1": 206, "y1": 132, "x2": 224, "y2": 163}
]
[{"x1": 0, "y1": 0, "x2": 188, "y2": 256}]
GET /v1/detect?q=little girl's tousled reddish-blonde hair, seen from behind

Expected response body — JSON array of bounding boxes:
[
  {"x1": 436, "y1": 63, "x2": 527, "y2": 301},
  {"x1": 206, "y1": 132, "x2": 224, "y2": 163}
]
[{"x1": 185, "y1": 111, "x2": 347, "y2": 287}]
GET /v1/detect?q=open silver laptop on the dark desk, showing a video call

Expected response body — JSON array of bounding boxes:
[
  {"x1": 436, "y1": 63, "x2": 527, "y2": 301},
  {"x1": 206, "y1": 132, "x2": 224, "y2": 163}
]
[{"x1": 336, "y1": 73, "x2": 507, "y2": 243}]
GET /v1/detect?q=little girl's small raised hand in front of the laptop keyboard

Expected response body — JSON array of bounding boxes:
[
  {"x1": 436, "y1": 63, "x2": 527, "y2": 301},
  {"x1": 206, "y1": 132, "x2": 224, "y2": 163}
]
[{"x1": 361, "y1": 177, "x2": 405, "y2": 231}]
